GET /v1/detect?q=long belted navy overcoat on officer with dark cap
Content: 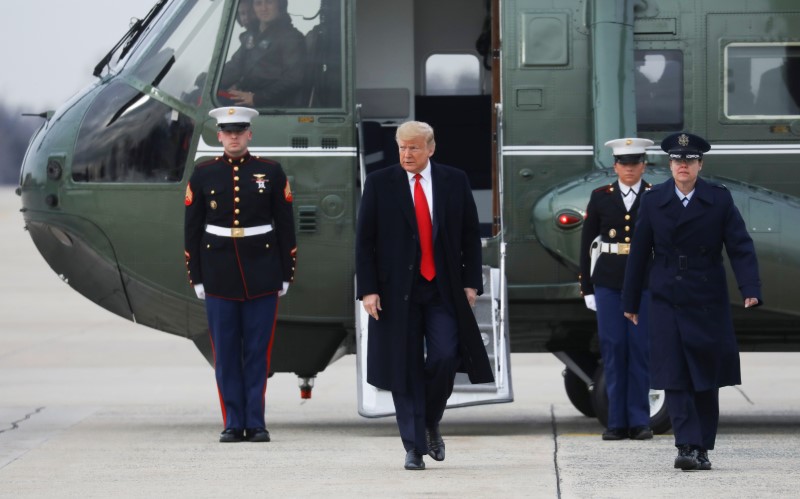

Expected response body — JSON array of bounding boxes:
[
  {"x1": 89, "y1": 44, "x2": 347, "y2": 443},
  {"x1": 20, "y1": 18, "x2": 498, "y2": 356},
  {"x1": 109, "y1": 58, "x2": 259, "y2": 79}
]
[{"x1": 622, "y1": 178, "x2": 762, "y2": 391}]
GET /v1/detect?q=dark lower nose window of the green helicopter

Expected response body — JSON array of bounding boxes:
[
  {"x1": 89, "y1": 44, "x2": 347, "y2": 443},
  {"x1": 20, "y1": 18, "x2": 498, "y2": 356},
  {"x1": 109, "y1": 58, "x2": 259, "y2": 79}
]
[{"x1": 72, "y1": 83, "x2": 194, "y2": 183}]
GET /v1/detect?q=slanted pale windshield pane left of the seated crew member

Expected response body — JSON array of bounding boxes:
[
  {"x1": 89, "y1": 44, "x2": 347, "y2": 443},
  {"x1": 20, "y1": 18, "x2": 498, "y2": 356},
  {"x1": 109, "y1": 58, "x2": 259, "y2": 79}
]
[{"x1": 132, "y1": 0, "x2": 223, "y2": 105}]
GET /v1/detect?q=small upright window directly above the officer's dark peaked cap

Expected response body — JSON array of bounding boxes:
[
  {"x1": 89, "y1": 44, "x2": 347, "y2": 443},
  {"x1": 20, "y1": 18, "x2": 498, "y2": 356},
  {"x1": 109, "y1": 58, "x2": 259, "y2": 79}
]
[{"x1": 633, "y1": 50, "x2": 683, "y2": 131}]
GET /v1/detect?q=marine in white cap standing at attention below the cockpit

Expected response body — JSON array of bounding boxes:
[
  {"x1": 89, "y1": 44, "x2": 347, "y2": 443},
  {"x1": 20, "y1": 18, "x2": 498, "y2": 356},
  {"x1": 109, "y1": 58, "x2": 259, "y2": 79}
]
[{"x1": 184, "y1": 107, "x2": 297, "y2": 442}]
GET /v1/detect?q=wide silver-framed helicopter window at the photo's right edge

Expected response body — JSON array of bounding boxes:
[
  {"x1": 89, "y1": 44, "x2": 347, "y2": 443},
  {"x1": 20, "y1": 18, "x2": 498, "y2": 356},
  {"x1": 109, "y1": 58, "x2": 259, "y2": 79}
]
[{"x1": 722, "y1": 42, "x2": 800, "y2": 122}]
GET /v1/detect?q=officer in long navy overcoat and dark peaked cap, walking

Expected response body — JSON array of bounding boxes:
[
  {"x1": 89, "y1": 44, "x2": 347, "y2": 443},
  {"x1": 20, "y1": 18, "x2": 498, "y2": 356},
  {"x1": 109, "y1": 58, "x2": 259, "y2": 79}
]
[{"x1": 622, "y1": 132, "x2": 763, "y2": 470}]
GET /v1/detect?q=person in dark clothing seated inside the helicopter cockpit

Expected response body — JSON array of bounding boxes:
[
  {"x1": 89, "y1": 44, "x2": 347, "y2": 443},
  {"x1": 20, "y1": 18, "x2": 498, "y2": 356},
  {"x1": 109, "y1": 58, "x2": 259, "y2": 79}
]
[{"x1": 217, "y1": 0, "x2": 306, "y2": 107}]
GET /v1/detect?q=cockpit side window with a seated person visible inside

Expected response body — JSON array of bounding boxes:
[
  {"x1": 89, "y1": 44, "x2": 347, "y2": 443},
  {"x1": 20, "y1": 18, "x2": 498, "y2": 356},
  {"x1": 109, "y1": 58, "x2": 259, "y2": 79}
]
[{"x1": 216, "y1": 0, "x2": 343, "y2": 110}]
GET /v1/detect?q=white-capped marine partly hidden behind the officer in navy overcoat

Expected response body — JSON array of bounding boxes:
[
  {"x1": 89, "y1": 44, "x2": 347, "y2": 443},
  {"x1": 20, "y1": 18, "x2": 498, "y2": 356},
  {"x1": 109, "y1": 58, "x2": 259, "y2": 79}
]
[{"x1": 580, "y1": 138, "x2": 653, "y2": 440}]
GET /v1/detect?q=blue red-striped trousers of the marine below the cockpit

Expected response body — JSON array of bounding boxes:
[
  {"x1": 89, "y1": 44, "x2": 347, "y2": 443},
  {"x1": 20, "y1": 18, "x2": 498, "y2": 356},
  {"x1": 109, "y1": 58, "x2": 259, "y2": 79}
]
[{"x1": 206, "y1": 292, "x2": 278, "y2": 430}]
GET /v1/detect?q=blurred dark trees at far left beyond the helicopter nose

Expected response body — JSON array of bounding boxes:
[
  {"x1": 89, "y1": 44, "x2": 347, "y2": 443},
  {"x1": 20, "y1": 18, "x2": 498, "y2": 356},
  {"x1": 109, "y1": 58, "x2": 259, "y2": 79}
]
[{"x1": 0, "y1": 103, "x2": 44, "y2": 185}]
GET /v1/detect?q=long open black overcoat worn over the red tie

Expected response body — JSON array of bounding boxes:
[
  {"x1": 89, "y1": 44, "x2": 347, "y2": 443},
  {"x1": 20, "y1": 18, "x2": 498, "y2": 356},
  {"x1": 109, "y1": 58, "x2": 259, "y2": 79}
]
[{"x1": 356, "y1": 162, "x2": 494, "y2": 393}]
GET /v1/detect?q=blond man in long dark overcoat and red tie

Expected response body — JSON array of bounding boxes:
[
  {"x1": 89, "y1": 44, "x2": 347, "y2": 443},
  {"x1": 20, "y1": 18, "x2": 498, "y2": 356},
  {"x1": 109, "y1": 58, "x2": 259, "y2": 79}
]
[{"x1": 356, "y1": 121, "x2": 494, "y2": 470}]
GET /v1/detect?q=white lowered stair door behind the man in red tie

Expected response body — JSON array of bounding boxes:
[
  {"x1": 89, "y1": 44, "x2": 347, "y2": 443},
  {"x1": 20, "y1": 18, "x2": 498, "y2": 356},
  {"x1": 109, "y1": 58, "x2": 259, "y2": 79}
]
[{"x1": 356, "y1": 265, "x2": 514, "y2": 417}]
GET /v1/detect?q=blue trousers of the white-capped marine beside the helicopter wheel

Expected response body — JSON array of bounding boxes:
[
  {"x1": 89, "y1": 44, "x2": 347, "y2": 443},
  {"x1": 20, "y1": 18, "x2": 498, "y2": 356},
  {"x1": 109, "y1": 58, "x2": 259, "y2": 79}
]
[{"x1": 594, "y1": 286, "x2": 650, "y2": 429}]
